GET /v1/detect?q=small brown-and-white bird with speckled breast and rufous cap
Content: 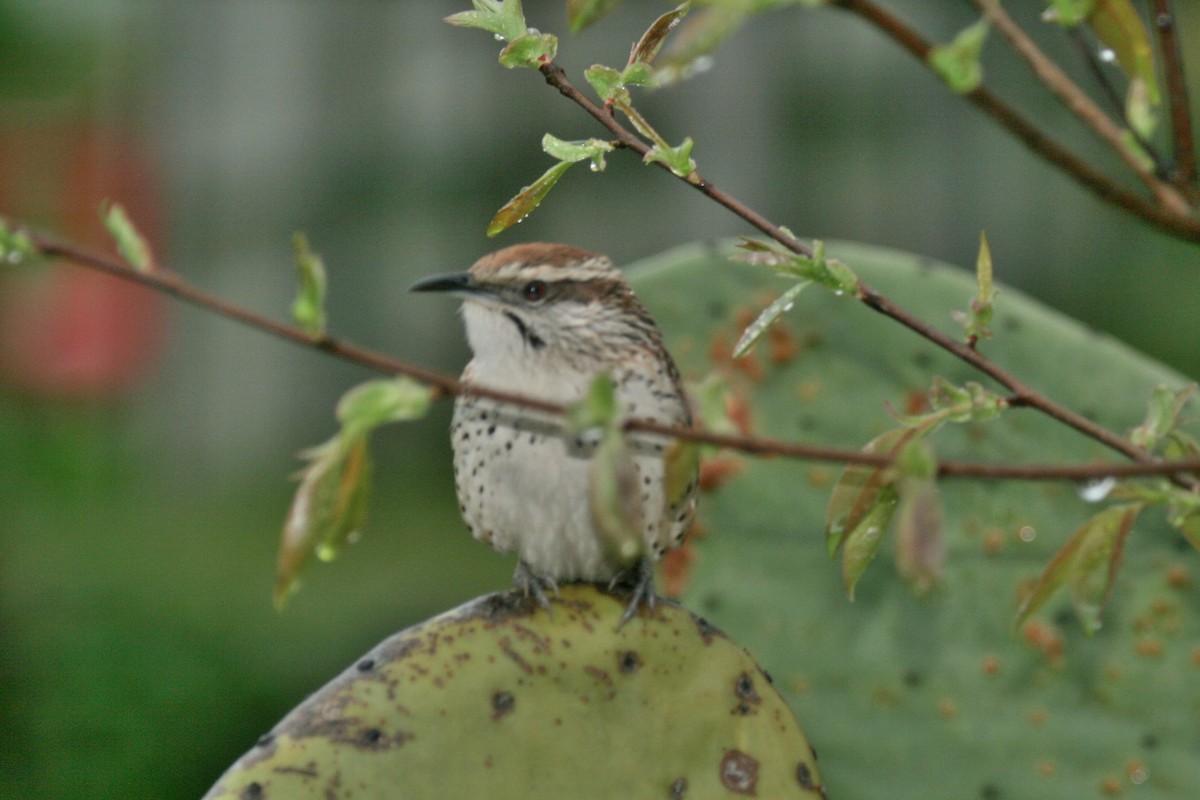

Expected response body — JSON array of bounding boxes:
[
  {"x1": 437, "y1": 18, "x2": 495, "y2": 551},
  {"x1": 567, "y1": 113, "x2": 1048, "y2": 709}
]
[{"x1": 412, "y1": 243, "x2": 697, "y2": 619}]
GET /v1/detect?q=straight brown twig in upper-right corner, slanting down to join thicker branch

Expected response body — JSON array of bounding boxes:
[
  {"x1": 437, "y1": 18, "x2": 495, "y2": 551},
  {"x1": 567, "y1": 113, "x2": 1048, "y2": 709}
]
[{"x1": 976, "y1": 0, "x2": 1192, "y2": 216}]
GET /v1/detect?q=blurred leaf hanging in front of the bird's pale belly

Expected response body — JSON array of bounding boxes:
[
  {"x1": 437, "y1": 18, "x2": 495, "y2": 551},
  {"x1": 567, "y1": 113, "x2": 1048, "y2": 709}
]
[{"x1": 588, "y1": 426, "x2": 646, "y2": 567}]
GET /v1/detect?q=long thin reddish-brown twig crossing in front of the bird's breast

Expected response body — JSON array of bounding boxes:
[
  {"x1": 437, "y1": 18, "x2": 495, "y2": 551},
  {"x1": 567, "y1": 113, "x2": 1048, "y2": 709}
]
[{"x1": 9, "y1": 217, "x2": 1200, "y2": 482}]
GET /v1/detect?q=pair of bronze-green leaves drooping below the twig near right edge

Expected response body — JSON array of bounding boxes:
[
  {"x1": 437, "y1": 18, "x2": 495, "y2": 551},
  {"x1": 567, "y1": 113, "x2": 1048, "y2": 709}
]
[{"x1": 1016, "y1": 503, "x2": 1144, "y2": 633}]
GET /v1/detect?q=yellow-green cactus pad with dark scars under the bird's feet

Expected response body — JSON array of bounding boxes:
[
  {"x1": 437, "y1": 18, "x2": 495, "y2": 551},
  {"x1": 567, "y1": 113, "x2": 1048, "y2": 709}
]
[{"x1": 206, "y1": 585, "x2": 824, "y2": 800}]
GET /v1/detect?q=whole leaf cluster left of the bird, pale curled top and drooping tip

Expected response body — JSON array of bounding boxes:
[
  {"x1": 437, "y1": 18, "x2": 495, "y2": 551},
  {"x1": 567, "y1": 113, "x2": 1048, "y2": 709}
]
[{"x1": 275, "y1": 378, "x2": 431, "y2": 608}]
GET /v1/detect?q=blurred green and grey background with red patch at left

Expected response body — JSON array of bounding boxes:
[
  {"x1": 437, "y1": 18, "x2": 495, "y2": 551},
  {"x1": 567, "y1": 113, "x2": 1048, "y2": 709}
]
[{"x1": 0, "y1": 0, "x2": 1200, "y2": 798}]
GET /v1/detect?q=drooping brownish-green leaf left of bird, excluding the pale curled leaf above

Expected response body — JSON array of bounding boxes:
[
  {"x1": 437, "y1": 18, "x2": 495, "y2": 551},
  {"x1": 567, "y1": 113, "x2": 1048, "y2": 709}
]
[{"x1": 275, "y1": 435, "x2": 371, "y2": 609}]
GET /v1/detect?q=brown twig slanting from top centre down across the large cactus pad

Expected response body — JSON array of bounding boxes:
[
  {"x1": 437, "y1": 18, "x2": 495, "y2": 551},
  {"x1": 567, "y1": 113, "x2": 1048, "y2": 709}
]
[{"x1": 541, "y1": 62, "x2": 1180, "y2": 474}]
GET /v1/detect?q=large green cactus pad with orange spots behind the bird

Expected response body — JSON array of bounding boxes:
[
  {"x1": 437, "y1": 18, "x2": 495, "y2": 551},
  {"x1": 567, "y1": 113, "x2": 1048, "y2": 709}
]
[{"x1": 629, "y1": 242, "x2": 1200, "y2": 800}]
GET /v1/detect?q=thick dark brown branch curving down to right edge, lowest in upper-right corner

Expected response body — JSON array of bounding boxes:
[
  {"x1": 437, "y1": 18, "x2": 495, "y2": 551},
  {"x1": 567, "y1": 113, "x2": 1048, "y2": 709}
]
[{"x1": 830, "y1": 0, "x2": 1200, "y2": 242}]
